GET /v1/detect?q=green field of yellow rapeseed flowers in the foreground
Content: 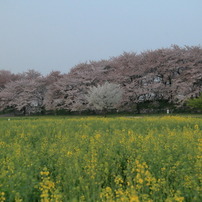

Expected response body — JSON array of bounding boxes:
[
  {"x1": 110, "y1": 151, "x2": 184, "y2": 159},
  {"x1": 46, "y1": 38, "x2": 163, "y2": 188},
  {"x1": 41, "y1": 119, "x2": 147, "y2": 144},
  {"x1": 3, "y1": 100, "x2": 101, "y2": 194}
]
[{"x1": 0, "y1": 116, "x2": 202, "y2": 202}]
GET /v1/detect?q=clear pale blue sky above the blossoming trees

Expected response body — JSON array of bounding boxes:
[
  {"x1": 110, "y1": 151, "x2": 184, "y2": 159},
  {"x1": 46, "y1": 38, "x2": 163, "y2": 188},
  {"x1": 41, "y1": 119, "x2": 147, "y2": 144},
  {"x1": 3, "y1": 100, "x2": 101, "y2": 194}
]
[{"x1": 0, "y1": 0, "x2": 202, "y2": 75}]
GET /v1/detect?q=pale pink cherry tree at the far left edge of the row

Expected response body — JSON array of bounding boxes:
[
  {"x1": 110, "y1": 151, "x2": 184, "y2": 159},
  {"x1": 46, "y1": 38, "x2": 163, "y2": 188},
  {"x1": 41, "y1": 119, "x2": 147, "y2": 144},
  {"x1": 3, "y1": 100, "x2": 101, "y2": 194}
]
[{"x1": 0, "y1": 72, "x2": 45, "y2": 115}]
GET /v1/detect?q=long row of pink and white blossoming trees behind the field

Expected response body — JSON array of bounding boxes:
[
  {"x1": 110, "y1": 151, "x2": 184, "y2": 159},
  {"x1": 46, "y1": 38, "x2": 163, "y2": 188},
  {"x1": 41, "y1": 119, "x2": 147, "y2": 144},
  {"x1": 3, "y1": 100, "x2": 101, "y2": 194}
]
[{"x1": 0, "y1": 45, "x2": 202, "y2": 114}]
